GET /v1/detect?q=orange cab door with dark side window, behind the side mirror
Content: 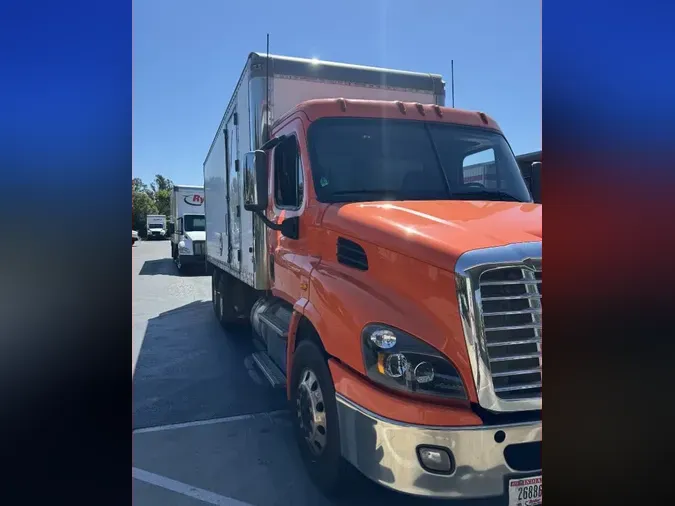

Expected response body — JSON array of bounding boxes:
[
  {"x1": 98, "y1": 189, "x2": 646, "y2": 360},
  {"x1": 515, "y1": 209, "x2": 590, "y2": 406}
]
[{"x1": 268, "y1": 133, "x2": 307, "y2": 303}]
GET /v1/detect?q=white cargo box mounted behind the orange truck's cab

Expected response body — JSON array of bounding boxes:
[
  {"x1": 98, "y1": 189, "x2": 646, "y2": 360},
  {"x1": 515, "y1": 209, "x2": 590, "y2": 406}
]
[{"x1": 204, "y1": 53, "x2": 445, "y2": 290}]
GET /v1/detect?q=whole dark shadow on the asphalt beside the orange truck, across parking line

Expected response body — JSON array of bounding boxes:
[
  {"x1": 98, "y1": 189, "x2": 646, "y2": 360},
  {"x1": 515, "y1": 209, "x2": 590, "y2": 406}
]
[{"x1": 132, "y1": 300, "x2": 505, "y2": 506}]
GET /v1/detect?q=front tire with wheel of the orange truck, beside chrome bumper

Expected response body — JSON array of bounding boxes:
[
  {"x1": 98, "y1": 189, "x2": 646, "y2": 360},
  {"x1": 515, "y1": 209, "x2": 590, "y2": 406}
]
[{"x1": 290, "y1": 341, "x2": 349, "y2": 497}]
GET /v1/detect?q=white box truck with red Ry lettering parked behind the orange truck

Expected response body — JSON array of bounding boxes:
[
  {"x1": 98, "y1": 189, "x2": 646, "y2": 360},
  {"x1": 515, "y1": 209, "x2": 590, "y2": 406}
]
[{"x1": 169, "y1": 185, "x2": 206, "y2": 271}]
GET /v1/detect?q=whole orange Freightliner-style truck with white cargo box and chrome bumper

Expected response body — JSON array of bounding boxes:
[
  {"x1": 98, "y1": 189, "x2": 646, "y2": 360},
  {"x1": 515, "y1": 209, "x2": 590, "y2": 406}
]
[{"x1": 204, "y1": 53, "x2": 542, "y2": 505}]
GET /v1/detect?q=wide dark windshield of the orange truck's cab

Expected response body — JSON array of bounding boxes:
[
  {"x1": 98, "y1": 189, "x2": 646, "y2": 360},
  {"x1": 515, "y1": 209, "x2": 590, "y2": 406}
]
[{"x1": 308, "y1": 118, "x2": 531, "y2": 202}]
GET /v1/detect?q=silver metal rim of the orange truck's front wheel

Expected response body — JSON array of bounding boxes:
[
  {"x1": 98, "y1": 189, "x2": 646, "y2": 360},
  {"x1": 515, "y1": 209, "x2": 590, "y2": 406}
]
[{"x1": 296, "y1": 369, "x2": 327, "y2": 455}]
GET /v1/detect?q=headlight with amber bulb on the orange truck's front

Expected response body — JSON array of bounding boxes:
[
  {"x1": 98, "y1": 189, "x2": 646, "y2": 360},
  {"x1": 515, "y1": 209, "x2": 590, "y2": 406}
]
[{"x1": 361, "y1": 323, "x2": 467, "y2": 399}]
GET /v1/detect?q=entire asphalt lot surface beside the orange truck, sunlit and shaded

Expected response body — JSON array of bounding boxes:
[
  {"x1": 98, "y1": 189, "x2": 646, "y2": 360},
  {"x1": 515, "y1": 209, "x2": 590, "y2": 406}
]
[{"x1": 132, "y1": 241, "x2": 502, "y2": 506}]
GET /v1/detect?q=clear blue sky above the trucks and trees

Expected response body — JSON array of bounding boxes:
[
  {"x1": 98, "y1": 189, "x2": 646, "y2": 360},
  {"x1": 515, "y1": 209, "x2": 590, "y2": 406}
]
[{"x1": 133, "y1": 0, "x2": 541, "y2": 185}]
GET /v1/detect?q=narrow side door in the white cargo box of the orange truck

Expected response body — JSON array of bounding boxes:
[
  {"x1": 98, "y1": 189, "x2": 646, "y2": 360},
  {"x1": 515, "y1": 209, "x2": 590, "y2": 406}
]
[{"x1": 225, "y1": 112, "x2": 241, "y2": 270}]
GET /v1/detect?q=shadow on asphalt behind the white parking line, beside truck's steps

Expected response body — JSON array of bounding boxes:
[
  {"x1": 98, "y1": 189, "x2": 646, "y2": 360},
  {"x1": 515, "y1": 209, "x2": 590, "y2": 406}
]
[{"x1": 132, "y1": 300, "x2": 286, "y2": 428}]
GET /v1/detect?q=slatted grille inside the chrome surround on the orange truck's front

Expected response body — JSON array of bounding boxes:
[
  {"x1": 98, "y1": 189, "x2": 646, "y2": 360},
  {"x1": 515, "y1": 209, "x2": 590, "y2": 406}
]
[{"x1": 479, "y1": 266, "x2": 542, "y2": 399}]
